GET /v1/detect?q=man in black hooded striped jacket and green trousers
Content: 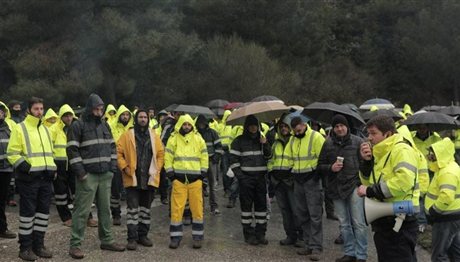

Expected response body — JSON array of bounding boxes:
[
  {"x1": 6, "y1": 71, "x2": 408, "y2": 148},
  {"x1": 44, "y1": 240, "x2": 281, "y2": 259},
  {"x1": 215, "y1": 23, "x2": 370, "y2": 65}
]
[{"x1": 66, "y1": 94, "x2": 125, "y2": 259}]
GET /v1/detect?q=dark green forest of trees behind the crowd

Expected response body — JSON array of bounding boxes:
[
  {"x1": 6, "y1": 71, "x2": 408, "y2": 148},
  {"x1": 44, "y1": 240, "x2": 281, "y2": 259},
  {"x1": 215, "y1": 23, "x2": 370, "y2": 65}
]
[{"x1": 0, "y1": 0, "x2": 460, "y2": 109}]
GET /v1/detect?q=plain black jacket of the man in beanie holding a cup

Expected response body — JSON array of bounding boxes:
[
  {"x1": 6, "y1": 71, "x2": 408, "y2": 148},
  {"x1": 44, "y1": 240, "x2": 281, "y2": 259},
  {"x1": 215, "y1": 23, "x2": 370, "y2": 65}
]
[{"x1": 317, "y1": 132, "x2": 363, "y2": 199}]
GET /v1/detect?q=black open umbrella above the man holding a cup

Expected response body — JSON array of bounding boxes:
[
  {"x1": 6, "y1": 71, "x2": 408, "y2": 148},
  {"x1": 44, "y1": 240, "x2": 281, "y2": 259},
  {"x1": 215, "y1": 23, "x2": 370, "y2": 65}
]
[{"x1": 303, "y1": 102, "x2": 364, "y2": 128}]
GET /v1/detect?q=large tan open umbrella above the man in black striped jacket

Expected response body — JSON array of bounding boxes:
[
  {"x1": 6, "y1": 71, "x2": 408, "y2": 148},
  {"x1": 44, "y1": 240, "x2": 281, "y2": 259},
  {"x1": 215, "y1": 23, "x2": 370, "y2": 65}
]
[{"x1": 227, "y1": 101, "x2": 289, "y2": 125}]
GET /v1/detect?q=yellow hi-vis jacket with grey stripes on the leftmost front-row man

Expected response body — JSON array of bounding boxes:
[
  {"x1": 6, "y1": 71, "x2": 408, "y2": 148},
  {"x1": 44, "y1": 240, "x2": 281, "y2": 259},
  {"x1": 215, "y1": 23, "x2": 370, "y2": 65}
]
[{"x1": 7, "y1": 115, "x2": 56, "y2": 172}]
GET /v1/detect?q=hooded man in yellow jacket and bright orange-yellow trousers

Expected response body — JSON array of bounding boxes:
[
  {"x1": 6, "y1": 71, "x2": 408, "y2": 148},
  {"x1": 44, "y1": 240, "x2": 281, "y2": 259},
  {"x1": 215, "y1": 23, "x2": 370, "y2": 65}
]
[{"x1": 164, "y1": 115, "x2": 208, "y2": 249}]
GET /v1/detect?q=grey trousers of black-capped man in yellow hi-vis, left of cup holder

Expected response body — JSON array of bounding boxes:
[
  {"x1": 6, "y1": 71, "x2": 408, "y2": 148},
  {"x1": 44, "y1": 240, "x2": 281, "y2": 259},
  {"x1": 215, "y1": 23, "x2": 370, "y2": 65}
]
[{"x1": 294, "y1": 178, "x2": 323, "y2": 251}]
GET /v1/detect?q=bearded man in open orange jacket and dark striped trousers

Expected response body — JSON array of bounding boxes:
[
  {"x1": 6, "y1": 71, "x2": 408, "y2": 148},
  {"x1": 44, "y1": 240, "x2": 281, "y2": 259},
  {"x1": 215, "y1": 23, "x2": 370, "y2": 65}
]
[{"x1": 117, "y1": 109, "x2": 164, "y2": 250}]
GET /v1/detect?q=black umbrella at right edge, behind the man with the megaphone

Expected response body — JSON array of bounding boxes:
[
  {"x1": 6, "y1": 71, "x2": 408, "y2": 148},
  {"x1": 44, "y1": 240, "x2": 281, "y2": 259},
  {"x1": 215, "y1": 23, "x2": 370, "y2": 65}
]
[{"x1": 402, "y1": 112, "x2": 460, "y2": 131}]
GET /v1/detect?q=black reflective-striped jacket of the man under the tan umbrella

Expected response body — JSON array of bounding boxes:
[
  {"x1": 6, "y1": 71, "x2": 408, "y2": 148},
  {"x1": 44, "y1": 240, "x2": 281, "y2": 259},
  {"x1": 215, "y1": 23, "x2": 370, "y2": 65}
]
[{"x1": 230, "y1": 116, "x2": 272, "y2": 179}]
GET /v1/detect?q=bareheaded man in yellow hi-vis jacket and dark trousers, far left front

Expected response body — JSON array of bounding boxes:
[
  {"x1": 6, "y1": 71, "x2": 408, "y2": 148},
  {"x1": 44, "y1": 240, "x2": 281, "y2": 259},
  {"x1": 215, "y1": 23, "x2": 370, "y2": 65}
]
[{"x1": 7, "y1": 97, "x2": 56, "y2": 261}]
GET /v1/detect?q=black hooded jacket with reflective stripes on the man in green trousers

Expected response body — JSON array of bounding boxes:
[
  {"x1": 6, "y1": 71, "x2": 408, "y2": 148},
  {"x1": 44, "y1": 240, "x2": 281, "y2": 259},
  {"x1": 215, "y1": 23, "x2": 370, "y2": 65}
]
[{"x1": 67, "y1": 94, "x2": 117, "y2": 177}]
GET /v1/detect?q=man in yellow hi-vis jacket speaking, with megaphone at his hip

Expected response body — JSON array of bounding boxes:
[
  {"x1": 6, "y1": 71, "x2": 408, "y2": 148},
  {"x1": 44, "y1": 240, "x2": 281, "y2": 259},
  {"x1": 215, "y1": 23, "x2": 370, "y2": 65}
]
[{"x1": 358, "y1": 115, "x2": 418, "y2": 261}]
